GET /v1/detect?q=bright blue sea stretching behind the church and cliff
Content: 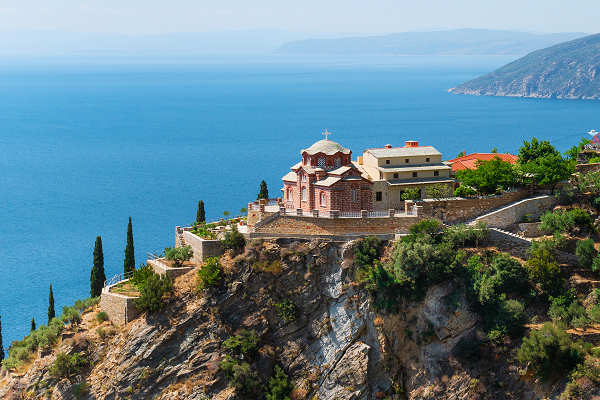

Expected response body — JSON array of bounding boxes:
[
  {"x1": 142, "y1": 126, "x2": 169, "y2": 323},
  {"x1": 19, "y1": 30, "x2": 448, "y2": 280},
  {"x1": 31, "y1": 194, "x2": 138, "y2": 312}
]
[{"x1": 0, "y1": 57, "x2": 600, "y2": 347}]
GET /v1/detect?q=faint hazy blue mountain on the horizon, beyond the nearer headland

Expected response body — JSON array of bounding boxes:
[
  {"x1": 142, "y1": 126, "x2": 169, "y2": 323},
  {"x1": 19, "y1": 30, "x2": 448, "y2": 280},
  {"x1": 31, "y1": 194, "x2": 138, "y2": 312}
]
[{"x1": 277, "y1": 29, "x2": 586, "y2": 55}]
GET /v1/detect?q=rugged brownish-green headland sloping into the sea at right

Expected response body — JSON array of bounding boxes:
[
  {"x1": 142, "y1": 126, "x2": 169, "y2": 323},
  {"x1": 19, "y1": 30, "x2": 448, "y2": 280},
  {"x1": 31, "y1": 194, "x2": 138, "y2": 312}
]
[{"x1": 449, "y1": 34, "x2": 600, "y2": 99}]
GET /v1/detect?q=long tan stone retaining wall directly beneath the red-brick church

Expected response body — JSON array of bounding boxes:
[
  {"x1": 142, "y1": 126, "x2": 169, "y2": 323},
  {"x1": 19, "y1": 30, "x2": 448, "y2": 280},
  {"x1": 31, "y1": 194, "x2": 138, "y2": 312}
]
[{"x1": 251, "y1": 215, "x2": 420, "y2": 237}]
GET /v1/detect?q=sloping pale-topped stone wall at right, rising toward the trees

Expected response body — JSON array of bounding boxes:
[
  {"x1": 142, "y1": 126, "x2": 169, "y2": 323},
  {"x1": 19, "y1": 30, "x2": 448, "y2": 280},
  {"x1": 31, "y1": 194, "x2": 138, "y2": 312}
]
[{"x1": 475, "y1": 195, "x2": 556, "y2": 228}]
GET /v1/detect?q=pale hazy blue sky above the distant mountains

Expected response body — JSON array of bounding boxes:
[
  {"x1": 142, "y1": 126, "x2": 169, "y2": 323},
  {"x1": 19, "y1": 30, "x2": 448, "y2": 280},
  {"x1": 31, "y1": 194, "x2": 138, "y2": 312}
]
[{"x1": 0, "y1": 0, "x2": 600, "y2": 34}]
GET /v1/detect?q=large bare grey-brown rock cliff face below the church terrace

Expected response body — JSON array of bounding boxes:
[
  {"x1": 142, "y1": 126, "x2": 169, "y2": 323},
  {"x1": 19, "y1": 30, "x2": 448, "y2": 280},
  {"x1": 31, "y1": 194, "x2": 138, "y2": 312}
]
[{"x1": 0, "y1": 242, "x2": 535, "y2": 400}]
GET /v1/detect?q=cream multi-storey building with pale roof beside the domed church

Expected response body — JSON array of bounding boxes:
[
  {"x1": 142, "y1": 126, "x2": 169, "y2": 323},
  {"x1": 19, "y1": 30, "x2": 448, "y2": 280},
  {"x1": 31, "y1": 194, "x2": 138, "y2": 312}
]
[{"x1": 358, "y1": 141, "x2": 454, "y2": 210}]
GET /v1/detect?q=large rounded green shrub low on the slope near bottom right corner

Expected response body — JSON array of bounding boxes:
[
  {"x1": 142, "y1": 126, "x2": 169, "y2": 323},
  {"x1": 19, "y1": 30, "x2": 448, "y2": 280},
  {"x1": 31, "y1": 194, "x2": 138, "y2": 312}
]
[{"x1": 517, "y1": 323, "x2": 584, "y2": 380}]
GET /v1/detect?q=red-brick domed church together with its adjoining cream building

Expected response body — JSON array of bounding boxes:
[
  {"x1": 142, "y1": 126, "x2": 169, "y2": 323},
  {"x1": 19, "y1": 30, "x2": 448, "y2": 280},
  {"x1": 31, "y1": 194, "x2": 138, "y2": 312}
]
[{"x1": 281, "y1": 131, "x2": 454, "y2": 212}]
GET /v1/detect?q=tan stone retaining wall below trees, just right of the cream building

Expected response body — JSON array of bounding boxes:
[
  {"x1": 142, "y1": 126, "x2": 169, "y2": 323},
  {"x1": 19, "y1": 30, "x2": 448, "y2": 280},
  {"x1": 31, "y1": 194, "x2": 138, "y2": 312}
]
[{"x1": 407, "y1": 190, "x2": 529, "y2": 223}]
